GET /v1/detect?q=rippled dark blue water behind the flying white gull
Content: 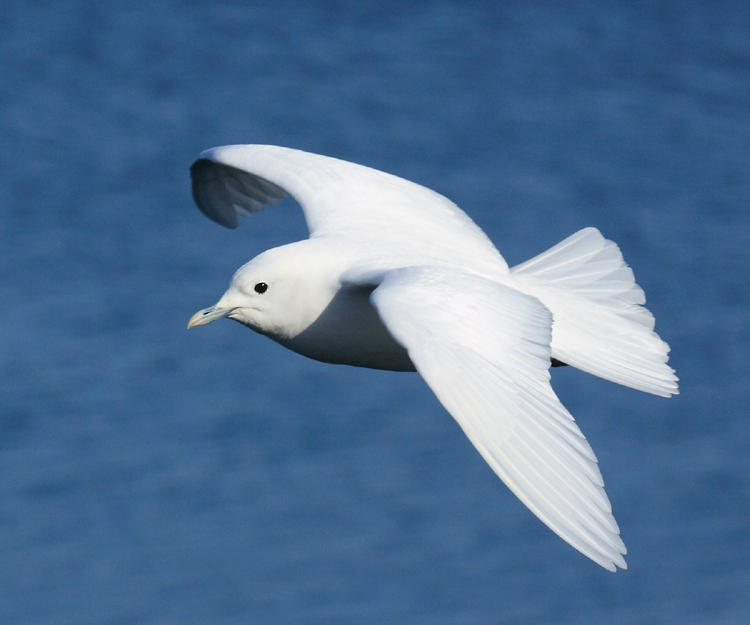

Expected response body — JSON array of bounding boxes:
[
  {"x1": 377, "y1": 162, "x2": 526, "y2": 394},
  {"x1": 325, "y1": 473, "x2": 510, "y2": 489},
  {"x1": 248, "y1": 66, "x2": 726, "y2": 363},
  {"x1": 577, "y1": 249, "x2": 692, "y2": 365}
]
[{"x1": 0, "y1": 0, "x2": 750, "y2": 625}]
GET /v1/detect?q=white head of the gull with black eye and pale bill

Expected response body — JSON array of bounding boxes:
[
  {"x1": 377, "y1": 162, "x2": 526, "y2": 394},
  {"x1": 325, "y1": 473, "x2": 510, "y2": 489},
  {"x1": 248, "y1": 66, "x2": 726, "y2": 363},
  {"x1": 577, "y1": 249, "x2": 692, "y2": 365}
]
[{"x1": 187, "y1": 244, "x2": 333, "y2": 341}]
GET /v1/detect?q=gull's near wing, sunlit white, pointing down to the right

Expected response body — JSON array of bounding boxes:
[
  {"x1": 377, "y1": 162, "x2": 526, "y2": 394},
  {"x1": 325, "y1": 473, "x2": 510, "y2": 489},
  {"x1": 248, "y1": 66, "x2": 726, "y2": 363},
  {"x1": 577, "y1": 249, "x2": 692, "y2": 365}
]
[{"x1": 362, "y1": 267, "x2": 626, "y2": 571}]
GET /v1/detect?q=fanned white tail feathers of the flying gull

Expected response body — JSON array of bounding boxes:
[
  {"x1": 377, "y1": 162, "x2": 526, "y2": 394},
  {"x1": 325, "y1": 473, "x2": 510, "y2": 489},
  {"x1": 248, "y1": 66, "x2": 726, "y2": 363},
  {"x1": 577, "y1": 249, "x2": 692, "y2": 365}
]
[{"x1": 511, "y1": 228, "x2": 679, "y2": 397}]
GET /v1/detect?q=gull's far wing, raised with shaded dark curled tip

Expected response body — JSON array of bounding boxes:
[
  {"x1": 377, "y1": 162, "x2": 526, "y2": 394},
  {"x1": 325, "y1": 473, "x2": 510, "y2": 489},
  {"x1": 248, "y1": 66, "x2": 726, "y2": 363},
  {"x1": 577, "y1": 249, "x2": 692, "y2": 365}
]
[{"x1": 190, "y1": 145, "x2": 507, "y2": 272}]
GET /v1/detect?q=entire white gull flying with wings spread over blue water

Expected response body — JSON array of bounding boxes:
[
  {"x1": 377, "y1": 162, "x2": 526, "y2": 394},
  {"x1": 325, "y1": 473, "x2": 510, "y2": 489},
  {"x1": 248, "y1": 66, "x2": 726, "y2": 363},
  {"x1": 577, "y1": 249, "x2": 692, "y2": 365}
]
[{"x1": 188, "y1": 145, "x2": 678, "y2": 570}]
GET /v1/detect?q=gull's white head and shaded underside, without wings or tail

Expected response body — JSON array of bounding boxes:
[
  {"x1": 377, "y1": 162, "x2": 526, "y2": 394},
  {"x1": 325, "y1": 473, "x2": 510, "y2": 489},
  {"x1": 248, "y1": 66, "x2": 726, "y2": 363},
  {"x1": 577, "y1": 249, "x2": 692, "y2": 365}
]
[{"x1": 200, "y1": 239, "x2": 414, "y2": 371}]
